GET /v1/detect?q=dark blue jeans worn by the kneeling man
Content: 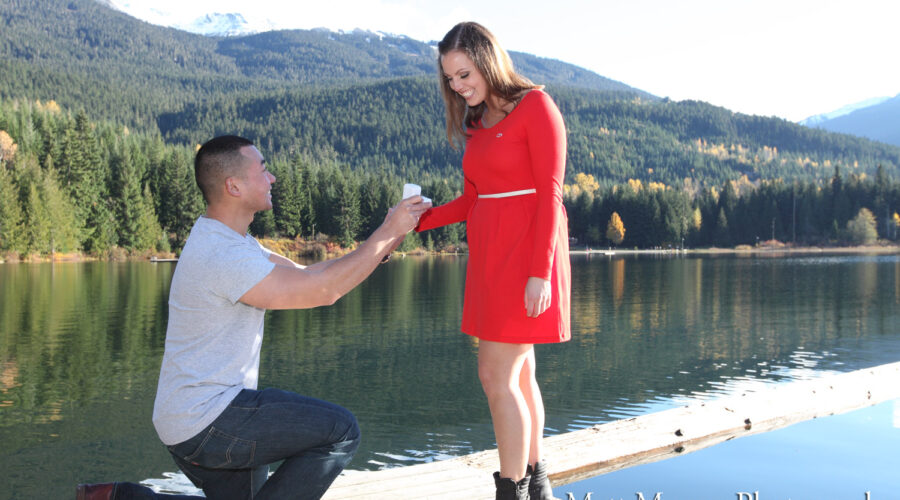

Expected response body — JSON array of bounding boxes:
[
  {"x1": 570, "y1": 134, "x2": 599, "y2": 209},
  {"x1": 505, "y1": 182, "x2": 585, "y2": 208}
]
[{"x1": 114, "y1": 389, "x2": 360, "y2": 500}]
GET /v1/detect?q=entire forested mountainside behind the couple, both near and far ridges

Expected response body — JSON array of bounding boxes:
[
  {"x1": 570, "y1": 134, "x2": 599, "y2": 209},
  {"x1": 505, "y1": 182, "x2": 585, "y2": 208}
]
[{"x1": 0, "y1": 0, "x2": 900, "y2": 185}]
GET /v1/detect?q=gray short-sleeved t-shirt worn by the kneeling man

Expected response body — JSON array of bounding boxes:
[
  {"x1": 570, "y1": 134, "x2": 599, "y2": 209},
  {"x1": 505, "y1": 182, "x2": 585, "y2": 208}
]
[{"x1": 153, "y1": 217, "x2": 275, "y2": 445}]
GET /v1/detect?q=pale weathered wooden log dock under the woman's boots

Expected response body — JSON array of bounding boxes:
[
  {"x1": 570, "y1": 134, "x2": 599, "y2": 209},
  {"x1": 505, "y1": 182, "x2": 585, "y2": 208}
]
[{"x1": 324, "y1": 362, "x2": 900, "y2": 500}]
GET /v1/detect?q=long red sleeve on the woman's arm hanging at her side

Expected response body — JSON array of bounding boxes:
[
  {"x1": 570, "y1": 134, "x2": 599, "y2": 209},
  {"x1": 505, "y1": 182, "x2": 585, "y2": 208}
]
[{"x1": 525, "y1": 91, "x2": 566, "y2": 279}]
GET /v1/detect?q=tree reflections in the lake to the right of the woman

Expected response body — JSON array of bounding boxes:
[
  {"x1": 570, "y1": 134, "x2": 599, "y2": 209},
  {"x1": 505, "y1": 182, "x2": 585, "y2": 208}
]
[{"x1": 560, "y1": 257, "x2": 900, "y2": 424}]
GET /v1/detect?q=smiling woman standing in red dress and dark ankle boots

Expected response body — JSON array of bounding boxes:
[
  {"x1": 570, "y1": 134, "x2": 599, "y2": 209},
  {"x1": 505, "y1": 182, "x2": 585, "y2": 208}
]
[{"x1": 417, "y1": 22, "x2": 570, "y2": 500}]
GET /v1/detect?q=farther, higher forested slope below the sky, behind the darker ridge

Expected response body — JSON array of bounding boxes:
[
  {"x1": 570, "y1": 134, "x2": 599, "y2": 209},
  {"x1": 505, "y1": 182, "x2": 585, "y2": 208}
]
[{"x1": 0, "y1": 0, "x2": 652, "y2": 131}]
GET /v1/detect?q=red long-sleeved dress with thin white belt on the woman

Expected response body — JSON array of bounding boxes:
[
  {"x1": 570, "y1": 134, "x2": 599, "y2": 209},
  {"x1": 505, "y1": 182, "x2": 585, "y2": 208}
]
[{"x1": 416, "y1": 90, "x2": 571, "y2": 344}]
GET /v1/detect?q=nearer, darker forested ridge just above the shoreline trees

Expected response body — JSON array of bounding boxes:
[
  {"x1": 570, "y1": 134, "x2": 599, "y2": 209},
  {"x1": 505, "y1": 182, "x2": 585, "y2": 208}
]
[{"x1": 159, "y1": 77, "x2": 900, "y2": 186}]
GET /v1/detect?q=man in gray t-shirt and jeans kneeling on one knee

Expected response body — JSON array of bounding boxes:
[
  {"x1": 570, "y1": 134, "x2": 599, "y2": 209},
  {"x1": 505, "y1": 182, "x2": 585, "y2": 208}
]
[{"x1": 76, "y1": 136, "x2": 431, "y2": 500}]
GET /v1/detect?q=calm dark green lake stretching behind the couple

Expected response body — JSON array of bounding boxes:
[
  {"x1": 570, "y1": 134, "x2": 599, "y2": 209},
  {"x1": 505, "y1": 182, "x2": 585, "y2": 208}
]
[{"x1": 0, "y1": 254, "x2": 900, "y2": 499}]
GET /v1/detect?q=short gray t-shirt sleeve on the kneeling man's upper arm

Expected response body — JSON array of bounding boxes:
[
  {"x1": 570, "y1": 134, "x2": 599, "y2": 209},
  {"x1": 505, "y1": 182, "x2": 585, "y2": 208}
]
[{"x1": 209, "y1": 237, "x2": 275, "y2": 304}]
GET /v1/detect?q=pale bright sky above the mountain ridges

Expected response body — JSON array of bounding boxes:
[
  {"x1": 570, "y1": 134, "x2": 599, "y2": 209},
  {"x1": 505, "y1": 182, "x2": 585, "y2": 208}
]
[{"x1": 114, "y1": 0, "x2": 900, "y2": 121}]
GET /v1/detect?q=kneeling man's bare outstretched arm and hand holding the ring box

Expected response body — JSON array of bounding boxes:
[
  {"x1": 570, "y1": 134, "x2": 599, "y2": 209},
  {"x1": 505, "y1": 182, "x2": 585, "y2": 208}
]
[{"x1": 240, "y1": 196, "x2": 431, "y2": 309}]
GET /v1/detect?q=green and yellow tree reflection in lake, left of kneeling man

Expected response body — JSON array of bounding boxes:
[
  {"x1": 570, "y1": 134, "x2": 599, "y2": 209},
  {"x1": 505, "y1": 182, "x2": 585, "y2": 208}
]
[{"x1": 0, "y1": 262, "x2": 173, "y2": 425}]
